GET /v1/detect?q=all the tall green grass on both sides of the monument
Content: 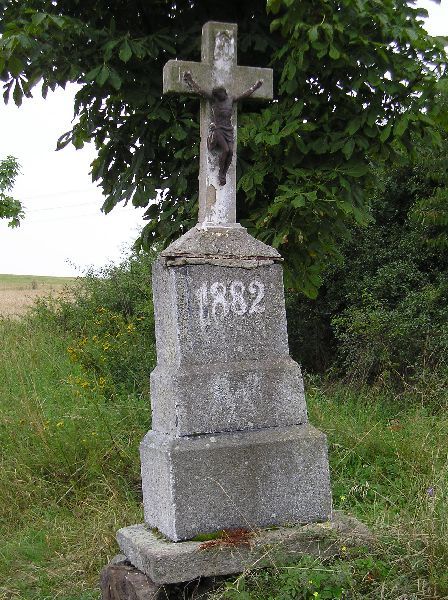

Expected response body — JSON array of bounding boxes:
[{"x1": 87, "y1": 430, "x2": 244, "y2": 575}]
[{"x1": 0, "y1": 318, "x2": 448, "y2": 600}]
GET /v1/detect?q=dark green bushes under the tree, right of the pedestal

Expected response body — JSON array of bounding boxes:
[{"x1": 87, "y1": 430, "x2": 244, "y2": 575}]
[{"x1": 287, "y1": 142, "x2": 448, "y2": 384}]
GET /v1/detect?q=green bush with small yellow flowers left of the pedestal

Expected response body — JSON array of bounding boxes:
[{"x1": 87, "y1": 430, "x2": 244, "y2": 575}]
[{"x1": 35, "y1": 254, "x2": 155, "y2": 397}]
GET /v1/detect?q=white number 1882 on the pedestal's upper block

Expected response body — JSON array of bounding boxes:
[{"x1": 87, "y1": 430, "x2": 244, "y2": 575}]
[{"x1": 196, "y1": 279, "x2": 265, "y2": 327}]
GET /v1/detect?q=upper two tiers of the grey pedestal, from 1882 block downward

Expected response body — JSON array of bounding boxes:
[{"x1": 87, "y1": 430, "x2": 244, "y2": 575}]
[{"x1": 151, "y1": 254, "x2": 307, "y2": 436}]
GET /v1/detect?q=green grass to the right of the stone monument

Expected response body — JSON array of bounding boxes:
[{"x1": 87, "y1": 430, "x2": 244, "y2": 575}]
[{"x1": 215, "y1": 381, "x2": 448, "y2": 600}]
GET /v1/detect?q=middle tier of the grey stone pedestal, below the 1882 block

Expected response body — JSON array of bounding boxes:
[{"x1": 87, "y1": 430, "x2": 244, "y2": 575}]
[{"x1": 151, "y1": 358, "x2": 307, "y2": 436}]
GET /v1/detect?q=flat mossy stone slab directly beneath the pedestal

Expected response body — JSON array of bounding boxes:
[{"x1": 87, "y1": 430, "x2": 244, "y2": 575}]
[{"x1": 117, "y1": 512, "x2": 374, "y2": 584}]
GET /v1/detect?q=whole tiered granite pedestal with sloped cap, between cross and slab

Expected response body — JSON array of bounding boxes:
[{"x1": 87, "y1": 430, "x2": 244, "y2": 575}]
[{"x1": 141, "y1": 227, "x2": 331, "y2": 541}]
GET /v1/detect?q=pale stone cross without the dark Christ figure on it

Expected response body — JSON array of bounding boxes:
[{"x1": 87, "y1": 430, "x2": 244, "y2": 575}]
[{"x1": 163, "y1": 21, "x2": 273, "y2": 229}]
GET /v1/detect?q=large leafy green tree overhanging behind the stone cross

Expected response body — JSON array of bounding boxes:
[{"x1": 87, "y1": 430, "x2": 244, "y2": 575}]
[{"x1": 0, "y1": 0, "x2": 446, "y2": 296}]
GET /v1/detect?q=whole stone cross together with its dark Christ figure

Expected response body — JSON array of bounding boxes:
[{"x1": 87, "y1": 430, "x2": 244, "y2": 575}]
[{"x1": 163, "y1": 21, "x2": 273, "y2": 229}]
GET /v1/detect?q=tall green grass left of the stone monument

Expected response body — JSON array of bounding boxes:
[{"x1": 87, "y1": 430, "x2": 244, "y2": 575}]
[{"x1": 0, "y1": 320, "x2": 149, "y2": 600}]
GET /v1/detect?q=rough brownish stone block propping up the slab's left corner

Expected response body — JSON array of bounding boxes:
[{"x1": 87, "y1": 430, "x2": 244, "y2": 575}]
[{"x1": 100, "y1": 555, "x2": 162, "y2": 600}]
